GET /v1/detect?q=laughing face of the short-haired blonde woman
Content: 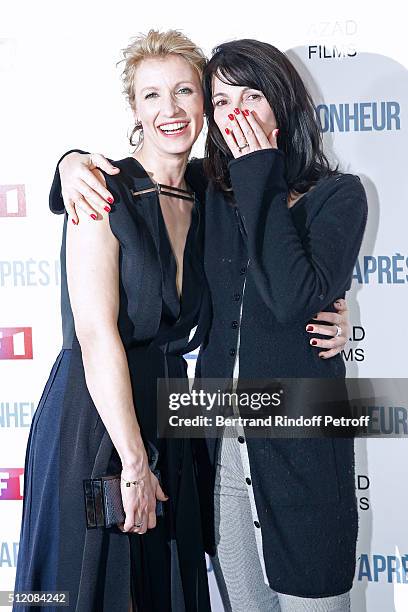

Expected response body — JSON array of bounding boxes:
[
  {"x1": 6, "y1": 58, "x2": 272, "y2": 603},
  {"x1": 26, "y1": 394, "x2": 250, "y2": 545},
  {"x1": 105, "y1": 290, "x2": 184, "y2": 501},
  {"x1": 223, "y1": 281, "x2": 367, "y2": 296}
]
[{"x1": 134, "y1": 54, "x2": 204, "y2": 155}]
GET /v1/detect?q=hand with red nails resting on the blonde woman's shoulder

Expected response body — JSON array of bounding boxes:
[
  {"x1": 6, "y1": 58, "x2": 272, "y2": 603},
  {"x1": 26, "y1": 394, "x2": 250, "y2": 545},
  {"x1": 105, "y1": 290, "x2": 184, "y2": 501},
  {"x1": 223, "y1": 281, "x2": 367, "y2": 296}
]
[{"x1": 58, "y1": 153, "x2": 120, "y2": 225}]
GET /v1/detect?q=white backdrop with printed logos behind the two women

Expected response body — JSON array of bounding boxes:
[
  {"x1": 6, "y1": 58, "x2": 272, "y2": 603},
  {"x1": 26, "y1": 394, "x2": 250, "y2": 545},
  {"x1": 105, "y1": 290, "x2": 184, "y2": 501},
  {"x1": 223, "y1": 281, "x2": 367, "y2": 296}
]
[{"x1": 0, "y1": 0, "x2": 408, "y2": 612}]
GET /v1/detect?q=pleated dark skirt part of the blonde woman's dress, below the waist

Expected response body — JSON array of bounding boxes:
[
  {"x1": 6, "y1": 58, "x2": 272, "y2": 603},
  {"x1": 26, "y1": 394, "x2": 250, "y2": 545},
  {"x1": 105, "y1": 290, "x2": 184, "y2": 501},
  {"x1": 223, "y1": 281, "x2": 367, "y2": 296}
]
[{"x1": 13, "y1": 339, "x2": 210, "y2": 612}]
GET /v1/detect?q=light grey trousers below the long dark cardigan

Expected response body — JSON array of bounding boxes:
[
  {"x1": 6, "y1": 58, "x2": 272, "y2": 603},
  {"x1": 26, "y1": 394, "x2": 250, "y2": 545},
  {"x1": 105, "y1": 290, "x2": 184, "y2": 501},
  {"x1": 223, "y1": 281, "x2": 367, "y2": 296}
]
[{"x1": 212, "y1": 432, "x2": 350, "y2": 612}]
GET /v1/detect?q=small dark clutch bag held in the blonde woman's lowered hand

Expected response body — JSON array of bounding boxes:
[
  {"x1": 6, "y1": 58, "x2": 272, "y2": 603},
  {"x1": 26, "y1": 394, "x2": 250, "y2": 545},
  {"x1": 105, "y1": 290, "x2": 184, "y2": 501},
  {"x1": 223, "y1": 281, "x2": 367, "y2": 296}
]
[{"x1": 83, "y1": 442, "x2": 163, "y2": 529}]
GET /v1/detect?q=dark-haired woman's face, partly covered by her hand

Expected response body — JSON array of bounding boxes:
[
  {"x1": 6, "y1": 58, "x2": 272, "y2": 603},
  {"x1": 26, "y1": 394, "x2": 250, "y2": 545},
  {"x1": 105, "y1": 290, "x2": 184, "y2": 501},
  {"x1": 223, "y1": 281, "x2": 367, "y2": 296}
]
[{"x1": 212, "y1": 75, "x2": 277, "y2": 138}]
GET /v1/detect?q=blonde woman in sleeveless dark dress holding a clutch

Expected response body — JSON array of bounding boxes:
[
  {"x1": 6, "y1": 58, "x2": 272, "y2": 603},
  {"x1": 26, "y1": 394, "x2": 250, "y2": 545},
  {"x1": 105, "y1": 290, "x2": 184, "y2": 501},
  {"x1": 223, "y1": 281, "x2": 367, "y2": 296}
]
[{"x1": 13, "y1": 31, "x2": 210, "y2": 612}]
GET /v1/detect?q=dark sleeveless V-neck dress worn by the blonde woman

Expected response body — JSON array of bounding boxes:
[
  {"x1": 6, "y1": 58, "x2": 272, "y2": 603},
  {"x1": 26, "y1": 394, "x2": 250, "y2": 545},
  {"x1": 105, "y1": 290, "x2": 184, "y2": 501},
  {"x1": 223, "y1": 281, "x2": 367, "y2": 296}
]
[{"x1": 13, "y1": 158, "x2": 210, "y2": 612}]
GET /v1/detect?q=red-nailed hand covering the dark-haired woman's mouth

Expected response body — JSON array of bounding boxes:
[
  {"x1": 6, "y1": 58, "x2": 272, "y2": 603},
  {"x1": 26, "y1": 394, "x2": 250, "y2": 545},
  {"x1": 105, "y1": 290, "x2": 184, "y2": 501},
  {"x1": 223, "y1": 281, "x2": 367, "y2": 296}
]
[{"x1": 223, "y1": 108, "x2": 279, "y2": 158}]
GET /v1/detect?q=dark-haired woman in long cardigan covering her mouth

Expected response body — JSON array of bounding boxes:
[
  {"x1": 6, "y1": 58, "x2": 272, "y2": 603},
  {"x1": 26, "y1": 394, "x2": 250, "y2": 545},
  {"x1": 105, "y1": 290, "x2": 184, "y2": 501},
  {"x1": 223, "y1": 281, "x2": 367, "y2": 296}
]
[{"x1": 49, "y1": 40, "x2": 367, "y2": 612}]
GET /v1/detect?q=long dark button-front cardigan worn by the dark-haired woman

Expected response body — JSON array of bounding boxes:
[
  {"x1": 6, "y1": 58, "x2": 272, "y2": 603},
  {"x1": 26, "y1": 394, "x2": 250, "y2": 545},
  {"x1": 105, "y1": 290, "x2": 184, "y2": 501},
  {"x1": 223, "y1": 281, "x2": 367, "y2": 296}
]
[{"x1": 196, "y1": 149, "x2": 367, "y2": 597}]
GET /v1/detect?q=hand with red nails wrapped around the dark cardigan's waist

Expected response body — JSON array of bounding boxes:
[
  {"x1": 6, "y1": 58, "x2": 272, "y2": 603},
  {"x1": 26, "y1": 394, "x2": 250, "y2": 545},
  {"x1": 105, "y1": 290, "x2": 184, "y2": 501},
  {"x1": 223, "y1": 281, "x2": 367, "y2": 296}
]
[{"x1": 306, "y1": 299, "x2": 351, "y2": 359}]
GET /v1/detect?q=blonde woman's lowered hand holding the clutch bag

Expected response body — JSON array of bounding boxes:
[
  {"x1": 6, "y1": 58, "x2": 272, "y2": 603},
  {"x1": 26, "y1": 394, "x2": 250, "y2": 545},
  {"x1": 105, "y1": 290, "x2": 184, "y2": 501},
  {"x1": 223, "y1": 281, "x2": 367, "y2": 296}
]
[{"x1": 118, "y1": 457, "x2": 168, "y2": 535}]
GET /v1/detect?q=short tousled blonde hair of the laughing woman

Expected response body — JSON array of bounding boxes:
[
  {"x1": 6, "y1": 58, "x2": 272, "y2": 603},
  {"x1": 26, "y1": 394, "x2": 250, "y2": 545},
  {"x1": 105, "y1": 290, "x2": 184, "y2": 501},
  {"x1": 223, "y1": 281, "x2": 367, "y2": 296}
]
[{"x1": 119, "y1": 30, "x2": 207, "y2": 145}]
